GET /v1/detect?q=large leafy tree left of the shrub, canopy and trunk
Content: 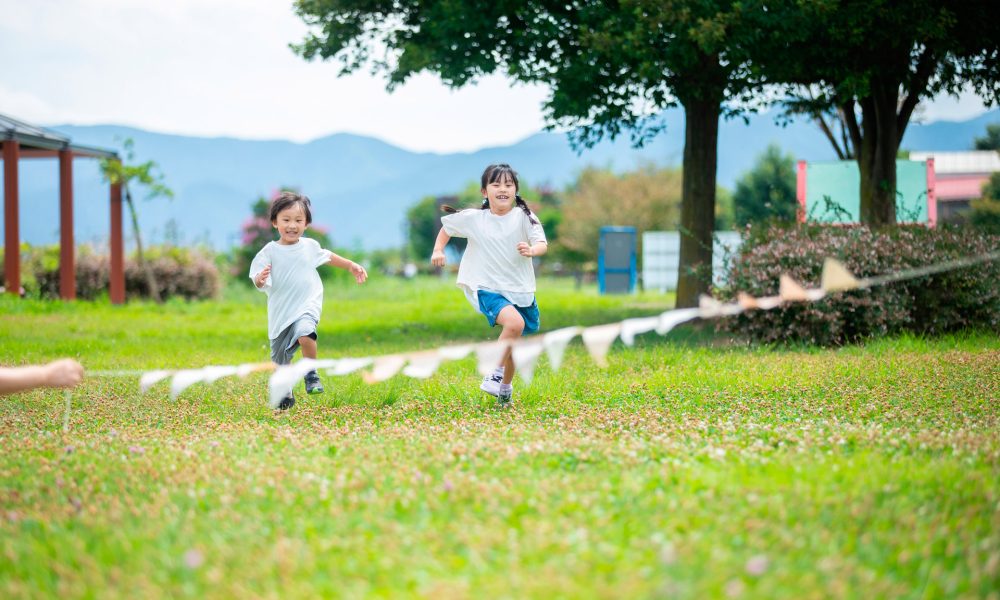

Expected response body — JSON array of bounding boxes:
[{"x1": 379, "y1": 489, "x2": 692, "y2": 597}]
[{"x1": 293, "y1": 0, "x2": 768, "y2": 306}]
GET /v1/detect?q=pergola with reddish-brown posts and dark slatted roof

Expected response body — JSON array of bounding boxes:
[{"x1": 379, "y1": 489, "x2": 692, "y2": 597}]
[{"x1": 0, "y1": 115, "x2": 125, "y2": 304}]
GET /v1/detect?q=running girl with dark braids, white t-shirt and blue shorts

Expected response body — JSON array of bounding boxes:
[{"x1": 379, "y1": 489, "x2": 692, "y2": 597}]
[{"x1": 431, "y1": 164, "x2": 548, "y2": 406}]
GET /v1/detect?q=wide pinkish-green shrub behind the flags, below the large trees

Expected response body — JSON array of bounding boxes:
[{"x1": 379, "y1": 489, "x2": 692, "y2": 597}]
[{"x1": 719, "y1": 225, "x2": 1000, "y2": 346}]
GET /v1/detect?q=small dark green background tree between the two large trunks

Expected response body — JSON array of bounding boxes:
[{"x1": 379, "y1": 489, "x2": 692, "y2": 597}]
[{"x1": 733, "y1": 144, "x2": 798, "y2": 227}]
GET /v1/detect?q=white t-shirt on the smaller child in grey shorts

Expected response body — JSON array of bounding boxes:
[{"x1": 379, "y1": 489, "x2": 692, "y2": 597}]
[{"x1": 250, "y1": 238, "x2": 333, "y2": 340}]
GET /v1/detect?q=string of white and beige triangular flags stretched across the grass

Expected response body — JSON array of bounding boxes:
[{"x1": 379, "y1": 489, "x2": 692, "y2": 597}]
[{"x1": 88, "y1": 251, "x2": 1000, "y2": 408}]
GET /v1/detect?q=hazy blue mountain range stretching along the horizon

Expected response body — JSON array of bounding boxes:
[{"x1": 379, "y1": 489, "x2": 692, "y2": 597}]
[{"x1": 5, "y1": 109, "x2": 1000, "y2": 250}]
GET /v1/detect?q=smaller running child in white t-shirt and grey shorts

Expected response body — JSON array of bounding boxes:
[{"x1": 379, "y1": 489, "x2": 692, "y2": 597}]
[{"x1": 250, "y1": 192, "x2": 368, "y2": 410}]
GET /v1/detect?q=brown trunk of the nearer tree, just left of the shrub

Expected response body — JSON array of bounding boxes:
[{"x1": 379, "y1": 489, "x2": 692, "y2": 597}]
[{"x1": 677, "y1": 94, "x2": 721, "y2": 308}]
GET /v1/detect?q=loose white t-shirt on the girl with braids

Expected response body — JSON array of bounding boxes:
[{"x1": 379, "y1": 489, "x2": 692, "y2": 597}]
[{"x1": 441, "y1": 206, "x2": 546, "y2": 311}]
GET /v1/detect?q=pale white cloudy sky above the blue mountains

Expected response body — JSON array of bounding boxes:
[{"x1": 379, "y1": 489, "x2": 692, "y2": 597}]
[{"x1": 0, "y1": 0, "x2": 986, "y2": 153}]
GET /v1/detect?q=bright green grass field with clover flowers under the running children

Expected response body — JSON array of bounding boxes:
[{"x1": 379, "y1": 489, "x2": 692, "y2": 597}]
[{"x1": 0, "y1": 280, "x2": 1000, "y2": 598}]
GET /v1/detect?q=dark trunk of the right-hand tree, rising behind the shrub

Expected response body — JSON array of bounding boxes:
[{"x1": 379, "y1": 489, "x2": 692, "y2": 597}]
[{"x1": 858, "y1": 78, "x2": 901, "y2": 227}]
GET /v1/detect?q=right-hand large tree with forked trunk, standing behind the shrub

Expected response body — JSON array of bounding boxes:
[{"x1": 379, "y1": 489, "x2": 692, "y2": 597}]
[{"x1": 751, "y1": 0, "x2": 1000, "y2": 225}]
